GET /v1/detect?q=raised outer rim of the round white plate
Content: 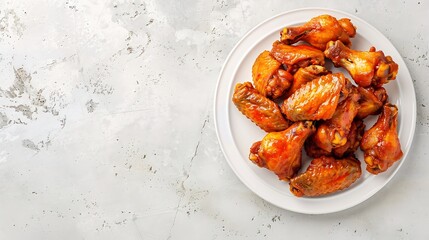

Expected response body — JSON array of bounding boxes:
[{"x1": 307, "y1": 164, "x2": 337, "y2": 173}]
[{"x1": 213, "y1": 7, "x2": 417, "y2": 214}]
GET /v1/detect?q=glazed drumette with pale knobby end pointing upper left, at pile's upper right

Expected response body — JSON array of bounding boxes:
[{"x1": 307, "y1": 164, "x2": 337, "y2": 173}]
[{"x1": 324, "y1": 40, "x2": 398, "y2": 87}]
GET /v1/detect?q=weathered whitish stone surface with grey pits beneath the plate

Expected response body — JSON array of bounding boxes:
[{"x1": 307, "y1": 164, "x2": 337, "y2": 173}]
[{"x1": 0, "y1": 0, "x2": 429, "y2": 240}]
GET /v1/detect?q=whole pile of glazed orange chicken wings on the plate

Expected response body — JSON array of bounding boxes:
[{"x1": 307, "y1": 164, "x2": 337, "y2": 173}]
[{"x1": 232, "y1": 15, "x2": 403, "y2": 197}]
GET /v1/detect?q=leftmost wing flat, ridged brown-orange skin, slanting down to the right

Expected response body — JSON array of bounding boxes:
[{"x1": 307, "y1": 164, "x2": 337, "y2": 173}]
[{"x1": 232, "y1": 82, "x2": 289, "y2": 132}]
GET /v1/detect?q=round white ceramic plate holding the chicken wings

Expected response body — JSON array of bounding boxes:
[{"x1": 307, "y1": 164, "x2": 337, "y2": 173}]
[{"x1": 214, "y1": 8, "x2": 416, "y2": 214}]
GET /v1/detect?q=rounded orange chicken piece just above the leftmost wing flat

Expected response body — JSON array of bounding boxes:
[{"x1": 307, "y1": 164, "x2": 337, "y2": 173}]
[{"x1": 252, "y1": 51, "x2": 293, "y2": 99}]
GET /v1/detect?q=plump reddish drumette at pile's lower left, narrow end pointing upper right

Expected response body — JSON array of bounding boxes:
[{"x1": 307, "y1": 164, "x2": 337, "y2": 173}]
[{"x1": 249, "y1": 121, "x2": 315, "y2": 180}]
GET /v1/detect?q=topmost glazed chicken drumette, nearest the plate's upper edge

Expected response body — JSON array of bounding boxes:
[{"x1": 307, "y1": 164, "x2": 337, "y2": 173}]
[{"x1": 280, "y1": 15, "x2": 356, "y2": 51}]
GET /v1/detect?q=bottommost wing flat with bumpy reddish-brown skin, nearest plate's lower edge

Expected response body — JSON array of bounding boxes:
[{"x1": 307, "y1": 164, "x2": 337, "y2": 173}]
[{"x1": 289, "y1": 156, "x2": 362, "y2": 197}]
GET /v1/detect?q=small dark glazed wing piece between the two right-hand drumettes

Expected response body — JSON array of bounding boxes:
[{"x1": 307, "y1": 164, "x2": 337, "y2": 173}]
[{"x1": 357, "y1": 87, "x2": 387, "y2": 119}]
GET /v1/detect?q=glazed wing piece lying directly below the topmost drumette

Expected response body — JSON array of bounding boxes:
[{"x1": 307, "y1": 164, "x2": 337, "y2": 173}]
[{"x1": 271, "y1": 41, "x2": 325, "y2": 73}]
